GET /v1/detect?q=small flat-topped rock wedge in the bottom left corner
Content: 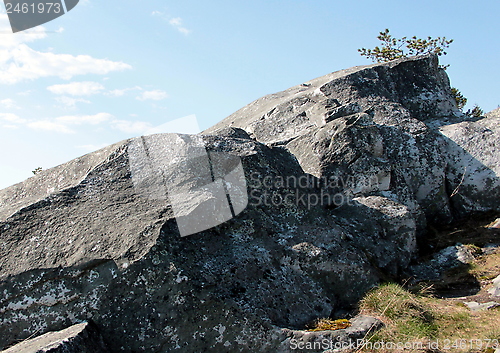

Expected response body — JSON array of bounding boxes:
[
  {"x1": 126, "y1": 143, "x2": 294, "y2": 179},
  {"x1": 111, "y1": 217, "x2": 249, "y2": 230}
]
[{"x1": 1, "y1": 322, "x2": 110, "y2": 353}]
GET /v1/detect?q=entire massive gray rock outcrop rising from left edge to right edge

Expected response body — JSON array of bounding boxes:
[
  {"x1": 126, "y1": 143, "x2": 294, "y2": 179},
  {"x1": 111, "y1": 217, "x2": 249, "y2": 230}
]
[{"x1": 0, "y1": 53, "x2": 500, "y2": 352}]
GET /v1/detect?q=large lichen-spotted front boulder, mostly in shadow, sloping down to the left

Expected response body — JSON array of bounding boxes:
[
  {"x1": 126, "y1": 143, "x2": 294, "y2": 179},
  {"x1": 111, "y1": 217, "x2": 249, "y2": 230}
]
[{"x1": 0, "y1": 133, "x2": 406, "y2": 352}]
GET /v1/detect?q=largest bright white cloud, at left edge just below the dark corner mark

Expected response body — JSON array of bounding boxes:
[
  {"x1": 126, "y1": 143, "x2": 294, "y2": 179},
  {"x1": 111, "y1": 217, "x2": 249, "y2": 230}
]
[{"x1": 0, "y1": 14, "x2": 131, "y2": 84}]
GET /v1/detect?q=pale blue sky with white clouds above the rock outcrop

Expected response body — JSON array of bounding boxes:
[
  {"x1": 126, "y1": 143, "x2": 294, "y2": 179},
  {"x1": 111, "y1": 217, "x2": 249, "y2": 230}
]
[{"x1": 0, "y1": 0, "x2": 500, "y2": 188}]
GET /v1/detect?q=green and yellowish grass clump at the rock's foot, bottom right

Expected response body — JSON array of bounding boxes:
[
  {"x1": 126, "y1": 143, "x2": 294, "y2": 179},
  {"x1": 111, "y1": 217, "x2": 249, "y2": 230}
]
[{"x1": 359, "y1": 283, "x2": 500, "y2": 353}]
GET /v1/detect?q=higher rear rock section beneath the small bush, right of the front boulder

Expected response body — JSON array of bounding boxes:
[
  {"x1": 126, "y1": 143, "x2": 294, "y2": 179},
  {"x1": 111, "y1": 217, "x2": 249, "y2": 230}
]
[{"x1": 206, "y1": 56, "x2": 500, "y2": 223}]
